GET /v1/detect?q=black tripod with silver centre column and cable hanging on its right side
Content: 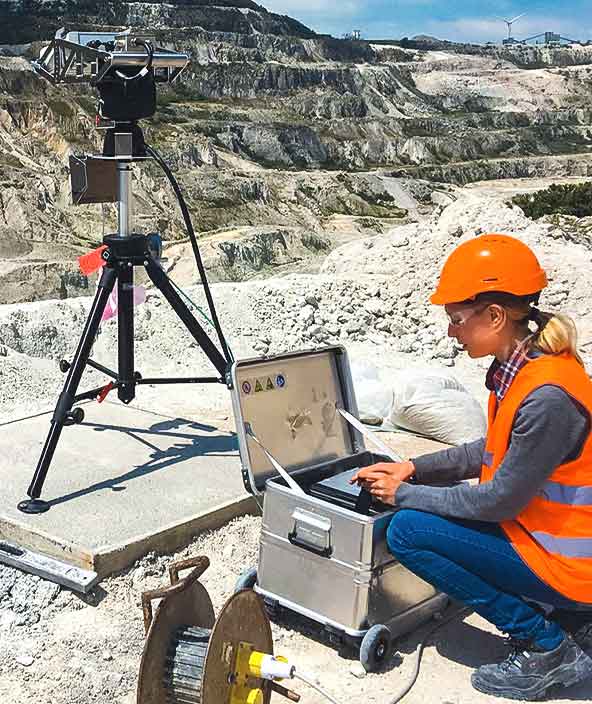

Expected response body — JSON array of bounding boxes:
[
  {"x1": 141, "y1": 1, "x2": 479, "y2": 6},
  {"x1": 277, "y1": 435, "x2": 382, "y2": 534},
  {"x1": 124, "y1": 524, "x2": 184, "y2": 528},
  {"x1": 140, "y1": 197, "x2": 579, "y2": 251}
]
[{"x1": 18, "y1": 123, "x2": 232, "y2": 513}]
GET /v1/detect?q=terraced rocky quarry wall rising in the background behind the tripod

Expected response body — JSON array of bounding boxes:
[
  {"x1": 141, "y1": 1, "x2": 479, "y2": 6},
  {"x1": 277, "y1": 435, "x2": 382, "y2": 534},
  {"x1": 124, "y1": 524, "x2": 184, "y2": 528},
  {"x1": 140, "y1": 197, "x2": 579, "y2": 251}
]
[{"x1": 0, "y1": 5, "x2": 592, "y2": 303}]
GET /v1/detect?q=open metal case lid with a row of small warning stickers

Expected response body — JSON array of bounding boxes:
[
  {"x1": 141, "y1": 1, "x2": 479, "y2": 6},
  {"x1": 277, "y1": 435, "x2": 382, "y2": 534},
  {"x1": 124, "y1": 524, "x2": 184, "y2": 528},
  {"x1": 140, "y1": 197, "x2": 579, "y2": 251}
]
[{"x1": 231, "y1": 346, "x2": 364, "y2": 493}]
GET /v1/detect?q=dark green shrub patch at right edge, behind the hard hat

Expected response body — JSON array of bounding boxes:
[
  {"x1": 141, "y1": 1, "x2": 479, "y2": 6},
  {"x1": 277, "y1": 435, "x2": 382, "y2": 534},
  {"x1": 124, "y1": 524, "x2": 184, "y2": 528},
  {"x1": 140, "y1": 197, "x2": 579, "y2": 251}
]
[{"x1": 512, "y1": 183, "x2": 592, "y2": 220}]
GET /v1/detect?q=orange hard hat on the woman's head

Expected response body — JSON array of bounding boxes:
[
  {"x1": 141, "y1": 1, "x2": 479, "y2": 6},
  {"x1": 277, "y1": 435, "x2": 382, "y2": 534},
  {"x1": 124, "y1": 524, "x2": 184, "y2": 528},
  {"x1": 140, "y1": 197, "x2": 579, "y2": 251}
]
[{"x1": 430, "y1": 234, "x2": 547, "y2": 306}]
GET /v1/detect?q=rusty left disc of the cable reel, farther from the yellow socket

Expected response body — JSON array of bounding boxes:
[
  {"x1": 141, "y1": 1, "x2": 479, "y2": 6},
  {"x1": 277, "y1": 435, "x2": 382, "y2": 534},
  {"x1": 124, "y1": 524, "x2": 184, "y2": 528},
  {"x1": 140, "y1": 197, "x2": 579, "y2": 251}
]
[{"x1": 137, "y1": 581, "x2": 215, "y2": 704}]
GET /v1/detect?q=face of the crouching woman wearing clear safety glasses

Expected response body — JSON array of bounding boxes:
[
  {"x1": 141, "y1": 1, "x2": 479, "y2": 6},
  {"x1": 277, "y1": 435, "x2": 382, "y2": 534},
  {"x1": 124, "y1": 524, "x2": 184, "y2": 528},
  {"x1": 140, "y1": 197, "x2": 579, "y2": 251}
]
[{"x1": 444, "y1": 303, "x2": 498, "y2": 359}]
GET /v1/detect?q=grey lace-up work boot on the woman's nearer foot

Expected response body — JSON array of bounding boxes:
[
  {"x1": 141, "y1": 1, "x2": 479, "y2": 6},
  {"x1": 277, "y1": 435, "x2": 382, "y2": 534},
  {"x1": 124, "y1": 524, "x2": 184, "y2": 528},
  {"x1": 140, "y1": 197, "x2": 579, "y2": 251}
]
[{"x1": 471, "y1": 636, "x2": 592, "y2": 701}]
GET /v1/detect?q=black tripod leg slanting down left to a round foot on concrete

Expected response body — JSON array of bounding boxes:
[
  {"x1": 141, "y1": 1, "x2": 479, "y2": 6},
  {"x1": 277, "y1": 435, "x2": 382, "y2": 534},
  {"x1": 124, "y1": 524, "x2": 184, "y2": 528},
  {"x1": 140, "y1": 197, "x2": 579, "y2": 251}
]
[{"x1": 18, "y1": 266, "x2": 117, "y2": 513}]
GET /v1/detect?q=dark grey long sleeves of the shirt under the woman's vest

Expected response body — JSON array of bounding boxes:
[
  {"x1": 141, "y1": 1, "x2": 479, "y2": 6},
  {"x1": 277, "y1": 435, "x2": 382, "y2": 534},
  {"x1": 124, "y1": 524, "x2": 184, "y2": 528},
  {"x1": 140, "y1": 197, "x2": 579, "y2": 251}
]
[{"x1": 395, "y1": 385, "x2": 590, "y2": 523}]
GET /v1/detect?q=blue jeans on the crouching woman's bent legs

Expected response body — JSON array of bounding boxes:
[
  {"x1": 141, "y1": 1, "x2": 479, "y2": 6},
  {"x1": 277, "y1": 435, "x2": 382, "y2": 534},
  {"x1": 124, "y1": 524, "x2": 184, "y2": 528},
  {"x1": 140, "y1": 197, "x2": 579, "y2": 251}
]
[{"x1": 387, "y1": 509, "x2": 579, "y2": 650}]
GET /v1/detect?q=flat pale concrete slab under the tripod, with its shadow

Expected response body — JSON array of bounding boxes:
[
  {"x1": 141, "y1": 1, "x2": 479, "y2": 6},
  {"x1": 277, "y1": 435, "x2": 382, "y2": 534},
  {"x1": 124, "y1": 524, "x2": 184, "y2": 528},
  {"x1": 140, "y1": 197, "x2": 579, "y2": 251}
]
[{"x1": 0, "y1": 402, "x2": 255, "y2": 576}]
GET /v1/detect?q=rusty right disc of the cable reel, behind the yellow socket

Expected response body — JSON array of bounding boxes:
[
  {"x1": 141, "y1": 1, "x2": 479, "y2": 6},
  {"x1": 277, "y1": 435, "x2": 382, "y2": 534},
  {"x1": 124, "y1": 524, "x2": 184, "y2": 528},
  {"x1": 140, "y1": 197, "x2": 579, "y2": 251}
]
[{"x1": 201, "y1": 589, "x2": 273, "y2": 704}]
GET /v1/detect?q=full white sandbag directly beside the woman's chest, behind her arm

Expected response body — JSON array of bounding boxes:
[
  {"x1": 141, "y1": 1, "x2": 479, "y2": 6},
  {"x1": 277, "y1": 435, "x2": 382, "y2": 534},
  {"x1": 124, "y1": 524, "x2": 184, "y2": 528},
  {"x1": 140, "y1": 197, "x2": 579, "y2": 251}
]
[{"x1": 388, "y1": 369, "x2": 487, "y2": 445}]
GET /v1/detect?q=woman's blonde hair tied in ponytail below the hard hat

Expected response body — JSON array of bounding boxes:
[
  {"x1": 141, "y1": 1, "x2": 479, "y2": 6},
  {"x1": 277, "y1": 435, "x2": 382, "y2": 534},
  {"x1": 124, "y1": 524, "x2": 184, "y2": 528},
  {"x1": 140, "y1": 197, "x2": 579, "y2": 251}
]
[{"x1": 476, "y1": 291, "x2": 584, "y2": 367}]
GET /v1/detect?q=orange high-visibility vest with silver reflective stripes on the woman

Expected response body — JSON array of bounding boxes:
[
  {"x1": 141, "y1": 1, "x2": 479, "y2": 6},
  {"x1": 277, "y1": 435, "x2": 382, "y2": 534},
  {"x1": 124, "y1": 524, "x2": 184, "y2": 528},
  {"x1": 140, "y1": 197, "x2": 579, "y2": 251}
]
[{"x1": 481, "y1": 353, "x2": 592, "y2": 604}]
